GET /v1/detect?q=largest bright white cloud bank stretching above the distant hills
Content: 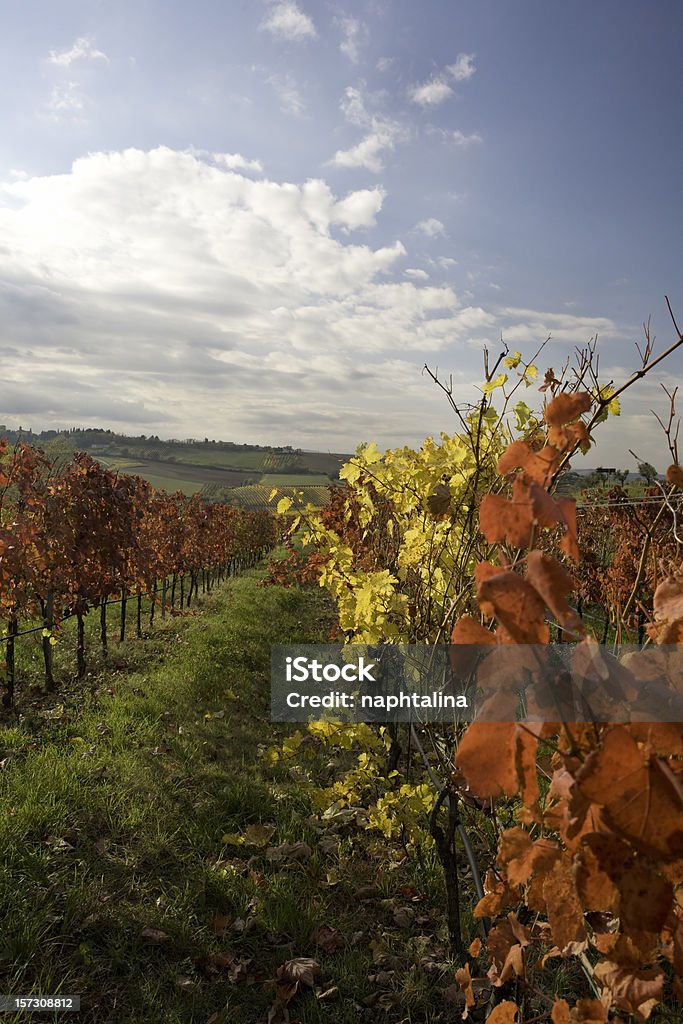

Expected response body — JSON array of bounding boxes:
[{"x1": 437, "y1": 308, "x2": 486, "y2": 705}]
[{"x1": 0, "y1": 146, "x2": 652, "y2": 456}]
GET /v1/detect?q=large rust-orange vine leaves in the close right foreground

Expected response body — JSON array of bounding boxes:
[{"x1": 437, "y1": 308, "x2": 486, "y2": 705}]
[{"x1": 452, "y1": 393, "x2": 683, "y2": 1024}]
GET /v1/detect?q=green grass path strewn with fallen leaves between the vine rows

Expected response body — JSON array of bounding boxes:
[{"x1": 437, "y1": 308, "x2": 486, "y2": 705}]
[{"x1": 0, "y1": 572, "x2": 456, "y2": 1024}]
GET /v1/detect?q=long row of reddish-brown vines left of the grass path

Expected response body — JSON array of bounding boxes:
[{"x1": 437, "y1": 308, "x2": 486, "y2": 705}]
[{"x1": 0, "y1": 440, "x2": 278, "y2": 708}]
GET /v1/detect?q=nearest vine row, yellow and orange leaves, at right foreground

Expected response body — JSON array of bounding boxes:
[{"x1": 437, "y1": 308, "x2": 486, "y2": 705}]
[{"x1": 267, "y1": 322, "x2": 683, "y2": 1024}]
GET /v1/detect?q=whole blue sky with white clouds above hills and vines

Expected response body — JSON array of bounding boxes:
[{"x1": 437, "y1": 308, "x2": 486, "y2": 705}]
[{"x1": 0, "y1": 0, "x2": 683, "y2": 468}]
